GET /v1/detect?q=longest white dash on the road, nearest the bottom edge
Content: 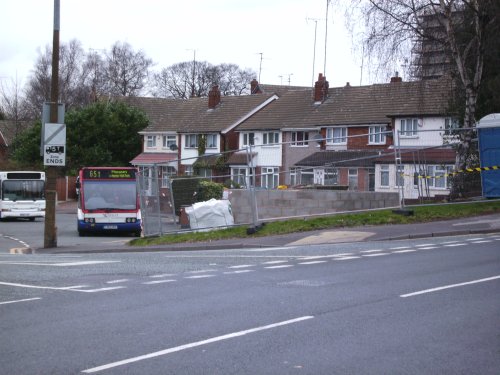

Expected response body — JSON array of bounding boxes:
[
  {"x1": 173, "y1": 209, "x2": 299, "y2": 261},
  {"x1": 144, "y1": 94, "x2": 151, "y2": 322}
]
[{"x1": 82, "y1": 316, "x2": 314, "y2": 374}]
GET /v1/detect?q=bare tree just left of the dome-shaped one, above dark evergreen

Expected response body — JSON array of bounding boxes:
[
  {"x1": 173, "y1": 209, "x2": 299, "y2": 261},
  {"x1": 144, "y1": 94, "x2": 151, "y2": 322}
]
[{"x1": 104, "y1": 42, "x2": 153, "y2": 96}]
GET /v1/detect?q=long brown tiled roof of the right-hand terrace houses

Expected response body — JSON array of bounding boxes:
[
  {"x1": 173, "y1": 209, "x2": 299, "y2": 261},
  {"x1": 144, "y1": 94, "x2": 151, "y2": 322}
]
[{"x1": 238, "y1": 77, "x2": 451, "y2": 130}]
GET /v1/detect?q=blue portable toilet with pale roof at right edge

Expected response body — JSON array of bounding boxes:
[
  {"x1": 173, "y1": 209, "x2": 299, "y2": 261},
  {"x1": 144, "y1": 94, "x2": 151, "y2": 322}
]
[{"x1": 476, "y1": 113, "x2": 500, "y2": 198}]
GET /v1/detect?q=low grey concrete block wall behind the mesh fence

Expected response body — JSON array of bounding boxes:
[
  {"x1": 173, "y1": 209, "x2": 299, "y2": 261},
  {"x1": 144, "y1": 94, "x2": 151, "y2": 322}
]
[{"x1": 229, "y1": 189, "x2": 399, "y2": 224}]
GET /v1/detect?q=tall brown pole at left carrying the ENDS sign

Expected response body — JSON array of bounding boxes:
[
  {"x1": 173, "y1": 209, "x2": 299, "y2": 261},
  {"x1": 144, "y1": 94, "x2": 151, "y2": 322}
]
[{"x1": 42, "y1": 0, "x2": 60, "y2": 248}]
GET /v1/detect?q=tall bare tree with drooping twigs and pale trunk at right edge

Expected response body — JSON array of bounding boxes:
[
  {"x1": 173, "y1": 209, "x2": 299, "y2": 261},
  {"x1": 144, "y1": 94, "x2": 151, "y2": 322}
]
[{"x1": 346, "y1": 0, "x2": 499, "y2": 169}]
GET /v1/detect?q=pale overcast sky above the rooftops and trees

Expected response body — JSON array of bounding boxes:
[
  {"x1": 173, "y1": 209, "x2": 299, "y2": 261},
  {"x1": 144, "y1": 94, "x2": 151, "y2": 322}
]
[{"x1": 0, "y1": 0, "x2": 373, "y2": 87}]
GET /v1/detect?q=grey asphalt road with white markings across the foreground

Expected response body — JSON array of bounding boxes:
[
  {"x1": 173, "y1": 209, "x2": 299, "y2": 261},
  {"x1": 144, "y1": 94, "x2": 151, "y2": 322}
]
[{"x1": 0, "y1": 234, "x2": 500, "y2": 375}]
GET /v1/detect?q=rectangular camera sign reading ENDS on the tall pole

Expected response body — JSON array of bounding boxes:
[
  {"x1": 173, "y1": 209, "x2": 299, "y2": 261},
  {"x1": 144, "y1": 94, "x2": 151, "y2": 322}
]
[{"x1": 43, "y1": 123, "x2": 66, "y2": 167}]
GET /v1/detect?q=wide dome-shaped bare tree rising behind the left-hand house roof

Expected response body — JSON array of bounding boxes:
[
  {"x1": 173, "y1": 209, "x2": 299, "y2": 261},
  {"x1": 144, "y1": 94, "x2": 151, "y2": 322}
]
[{"x1": 152, "y1": 61, "x2": 255, "y2": 99}]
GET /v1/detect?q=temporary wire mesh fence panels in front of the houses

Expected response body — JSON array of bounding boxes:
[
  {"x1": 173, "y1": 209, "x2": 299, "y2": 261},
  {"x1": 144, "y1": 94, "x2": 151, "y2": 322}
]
[{"x1": 138, "y1": 127, "x2": 496, "y2": 236}]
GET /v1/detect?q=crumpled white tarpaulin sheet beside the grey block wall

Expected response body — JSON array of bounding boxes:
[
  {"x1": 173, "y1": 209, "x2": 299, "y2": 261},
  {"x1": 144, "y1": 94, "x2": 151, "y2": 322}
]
[{"x1": 185, "y1": 199, "x2": 234, "y2": 229}]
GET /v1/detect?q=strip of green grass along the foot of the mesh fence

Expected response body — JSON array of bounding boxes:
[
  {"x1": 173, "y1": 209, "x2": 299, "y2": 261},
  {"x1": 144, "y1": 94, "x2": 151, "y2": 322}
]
[{"x1": 130, "y1": 201, "x2": 500, "y2": 246}]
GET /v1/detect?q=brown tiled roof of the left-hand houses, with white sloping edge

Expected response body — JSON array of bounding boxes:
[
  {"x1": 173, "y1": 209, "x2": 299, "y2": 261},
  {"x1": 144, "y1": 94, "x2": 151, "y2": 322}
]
[{"x1": 121, "y1": 94, "x2": 273, "y2": 133}]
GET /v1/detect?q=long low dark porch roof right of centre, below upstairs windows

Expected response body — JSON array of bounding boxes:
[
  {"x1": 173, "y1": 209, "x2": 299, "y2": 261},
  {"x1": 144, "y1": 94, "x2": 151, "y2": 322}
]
[{"x1": 295, "y1": 150, "x2": 388, "y2": 167}]
